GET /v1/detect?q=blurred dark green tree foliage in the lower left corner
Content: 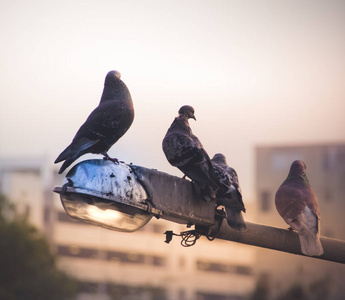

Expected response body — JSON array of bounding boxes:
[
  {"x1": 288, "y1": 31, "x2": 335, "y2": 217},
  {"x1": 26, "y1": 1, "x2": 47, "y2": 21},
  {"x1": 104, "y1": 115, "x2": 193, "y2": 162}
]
[{"x1": 0, "y1": 195, "x2": 76, "y2": 300}]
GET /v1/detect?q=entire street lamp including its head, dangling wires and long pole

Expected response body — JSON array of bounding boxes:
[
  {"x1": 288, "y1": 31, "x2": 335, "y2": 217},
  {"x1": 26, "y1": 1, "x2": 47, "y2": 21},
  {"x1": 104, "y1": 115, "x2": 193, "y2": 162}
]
[{"x1": 54, "y1": 159, "x2": 345, "y2": 263}]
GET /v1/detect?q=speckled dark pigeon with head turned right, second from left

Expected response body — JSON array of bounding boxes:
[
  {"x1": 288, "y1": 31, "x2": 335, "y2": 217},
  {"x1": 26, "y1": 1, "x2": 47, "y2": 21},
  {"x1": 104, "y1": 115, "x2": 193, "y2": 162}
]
[{"x1": 162, "y1": 105, "x2": 219, "y2": 201}]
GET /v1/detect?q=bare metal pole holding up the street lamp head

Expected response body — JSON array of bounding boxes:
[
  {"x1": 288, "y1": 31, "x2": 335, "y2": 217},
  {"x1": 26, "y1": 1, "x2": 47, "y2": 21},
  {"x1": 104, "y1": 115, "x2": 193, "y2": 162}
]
[{"x1": 196, "y1": 220, "x2": 345, "y2": 264}]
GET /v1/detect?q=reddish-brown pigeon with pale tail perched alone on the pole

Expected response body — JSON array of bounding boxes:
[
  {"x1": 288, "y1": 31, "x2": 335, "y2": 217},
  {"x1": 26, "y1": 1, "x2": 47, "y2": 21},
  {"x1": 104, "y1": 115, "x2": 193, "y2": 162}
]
[{"x1": 275, "y1": 160, "x2": 323, "y2": 256}]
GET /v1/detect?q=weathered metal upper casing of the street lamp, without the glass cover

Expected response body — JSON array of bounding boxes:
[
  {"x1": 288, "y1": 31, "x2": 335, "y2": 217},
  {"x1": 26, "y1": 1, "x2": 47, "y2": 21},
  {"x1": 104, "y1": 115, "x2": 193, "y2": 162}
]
[{"x1": 54, "y1": 159, "x2": 215, "y2": 226}]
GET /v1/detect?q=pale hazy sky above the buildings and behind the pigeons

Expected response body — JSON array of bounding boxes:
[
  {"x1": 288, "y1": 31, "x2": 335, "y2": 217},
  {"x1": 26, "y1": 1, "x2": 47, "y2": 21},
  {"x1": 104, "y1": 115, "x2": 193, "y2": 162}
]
[{"x1": 0, "y1": 0, "x2": 345, "y2": 198}]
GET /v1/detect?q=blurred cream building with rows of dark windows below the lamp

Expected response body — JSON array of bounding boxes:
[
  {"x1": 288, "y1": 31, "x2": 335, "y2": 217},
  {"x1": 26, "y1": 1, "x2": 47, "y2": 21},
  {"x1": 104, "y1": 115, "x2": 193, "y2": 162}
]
[{"x1": 0, "y1": 158, "x2": 255, "y2": 300}]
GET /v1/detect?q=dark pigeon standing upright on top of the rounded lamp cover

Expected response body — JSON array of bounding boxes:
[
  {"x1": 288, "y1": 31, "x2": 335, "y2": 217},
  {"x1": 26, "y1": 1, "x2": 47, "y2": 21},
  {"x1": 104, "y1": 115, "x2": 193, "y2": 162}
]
[{"x1": 55, "y1": 71, "x2": 134, "y2": 174}]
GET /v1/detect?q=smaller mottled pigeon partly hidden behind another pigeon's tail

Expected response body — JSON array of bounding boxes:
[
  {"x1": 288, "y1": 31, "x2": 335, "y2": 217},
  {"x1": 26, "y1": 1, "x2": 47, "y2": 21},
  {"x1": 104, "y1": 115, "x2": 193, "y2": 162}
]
[{"x1": 211, "y1": 153, "x2": 247, "y2": 231}]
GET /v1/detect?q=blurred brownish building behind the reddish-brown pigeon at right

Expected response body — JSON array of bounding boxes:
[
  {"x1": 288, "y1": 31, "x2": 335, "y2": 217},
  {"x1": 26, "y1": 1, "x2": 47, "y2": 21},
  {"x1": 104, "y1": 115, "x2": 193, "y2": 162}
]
[{"x1": 255, "y1": 143, "x2": 345, "y2": 299}]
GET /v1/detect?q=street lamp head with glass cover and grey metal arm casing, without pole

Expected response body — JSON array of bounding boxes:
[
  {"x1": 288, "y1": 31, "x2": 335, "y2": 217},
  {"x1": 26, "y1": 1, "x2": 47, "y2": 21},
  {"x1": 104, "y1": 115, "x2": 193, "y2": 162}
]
[{"x1": 54, "y1": 159, "x2": 215, "y2": 232}]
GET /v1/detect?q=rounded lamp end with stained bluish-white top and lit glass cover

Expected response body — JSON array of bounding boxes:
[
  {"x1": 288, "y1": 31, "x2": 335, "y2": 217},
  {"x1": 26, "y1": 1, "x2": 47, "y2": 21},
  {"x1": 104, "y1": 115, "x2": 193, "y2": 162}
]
[{"x1": 54, "y1": 160, "x2": 152, "y2": 232}]
